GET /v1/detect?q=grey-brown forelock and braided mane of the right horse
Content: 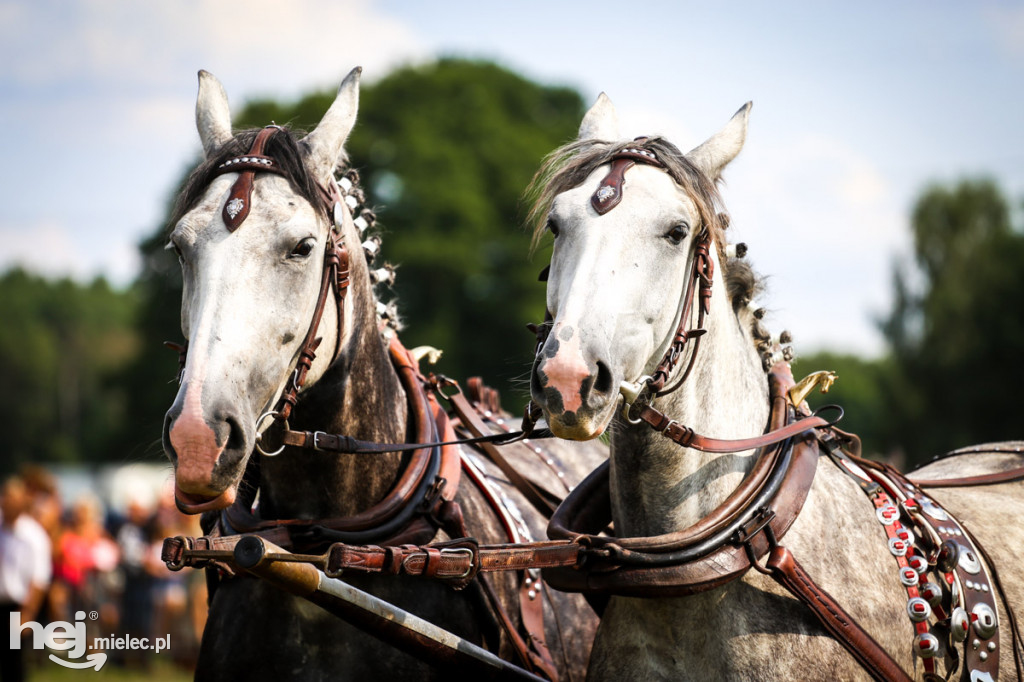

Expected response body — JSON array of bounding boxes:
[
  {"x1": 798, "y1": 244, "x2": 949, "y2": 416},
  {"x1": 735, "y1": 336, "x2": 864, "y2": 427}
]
[{"x1": 524, "y1": 136, "x2": 774, "y2": 364}]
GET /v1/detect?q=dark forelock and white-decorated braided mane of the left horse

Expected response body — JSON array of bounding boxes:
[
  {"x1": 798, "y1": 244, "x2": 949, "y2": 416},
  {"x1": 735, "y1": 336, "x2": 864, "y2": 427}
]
[{"x1": 168, "y1": 127, "x2": 401, "y2": 335}]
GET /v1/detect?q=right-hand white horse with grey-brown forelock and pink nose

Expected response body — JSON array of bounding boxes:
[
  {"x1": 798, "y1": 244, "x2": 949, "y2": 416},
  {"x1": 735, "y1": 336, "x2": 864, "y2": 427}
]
[{"x1": 532, "y1": 94, "x2": 1024, "y2": 680}]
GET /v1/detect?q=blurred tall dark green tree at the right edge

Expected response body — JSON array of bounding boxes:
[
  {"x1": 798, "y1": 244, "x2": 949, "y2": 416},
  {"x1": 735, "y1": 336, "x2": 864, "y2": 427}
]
[{"x1": 883, "y1": 180, "x2": 1024, "y2": 462}]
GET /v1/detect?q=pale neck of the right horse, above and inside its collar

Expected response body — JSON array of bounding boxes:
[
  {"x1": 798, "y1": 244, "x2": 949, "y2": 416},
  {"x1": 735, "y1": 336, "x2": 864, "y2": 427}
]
[{"x1": 610, "y1": 249, "x2": 769, "y2": 536}]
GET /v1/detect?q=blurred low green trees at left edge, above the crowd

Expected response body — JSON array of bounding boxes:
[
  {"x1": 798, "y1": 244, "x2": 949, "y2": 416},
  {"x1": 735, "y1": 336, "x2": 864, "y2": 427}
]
[{"x1": 0, "y1": 268, "x2": 138, "y2": 472}]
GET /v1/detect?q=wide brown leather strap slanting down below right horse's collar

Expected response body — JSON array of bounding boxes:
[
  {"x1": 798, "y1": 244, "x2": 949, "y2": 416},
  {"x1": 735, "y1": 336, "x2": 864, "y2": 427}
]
[{"x1": 768, "y1": 546, "x2": 911, "y2": 682}]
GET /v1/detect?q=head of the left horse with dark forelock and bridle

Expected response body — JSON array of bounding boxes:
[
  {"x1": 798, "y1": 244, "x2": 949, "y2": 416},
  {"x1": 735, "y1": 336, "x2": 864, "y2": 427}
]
[{"x1": 163, "y1": 69, "x2": 360, "y2": 513}]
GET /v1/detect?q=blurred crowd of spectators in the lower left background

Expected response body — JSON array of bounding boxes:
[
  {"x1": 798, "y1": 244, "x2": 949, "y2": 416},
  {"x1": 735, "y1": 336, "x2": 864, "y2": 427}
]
[{"x1": 0, "y1": 467, "x2": 206, "y2": 682}]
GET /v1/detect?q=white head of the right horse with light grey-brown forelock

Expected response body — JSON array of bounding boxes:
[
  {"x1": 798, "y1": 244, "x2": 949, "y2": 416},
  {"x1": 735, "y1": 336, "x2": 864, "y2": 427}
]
[{"x1": 531, "y1": 93, "x2": 750, "y2": 439}]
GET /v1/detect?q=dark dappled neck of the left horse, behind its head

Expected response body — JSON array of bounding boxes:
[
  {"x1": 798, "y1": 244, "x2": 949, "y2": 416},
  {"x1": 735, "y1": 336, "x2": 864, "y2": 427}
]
[{"x1": 260, "y1": 225, "x2": 408, "y2": 518}]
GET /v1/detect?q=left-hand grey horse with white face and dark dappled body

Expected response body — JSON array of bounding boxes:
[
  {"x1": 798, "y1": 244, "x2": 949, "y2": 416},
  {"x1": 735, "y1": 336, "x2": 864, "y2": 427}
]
[{"x1": 164, "y1": 70, "x2": 602, "y2": 680}]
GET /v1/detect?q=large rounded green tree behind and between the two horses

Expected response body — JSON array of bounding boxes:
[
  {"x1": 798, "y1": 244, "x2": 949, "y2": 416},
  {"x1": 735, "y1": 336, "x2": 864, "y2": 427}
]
[{"x1": 119, "y1": 59, "x2": 583, "y2": 456}]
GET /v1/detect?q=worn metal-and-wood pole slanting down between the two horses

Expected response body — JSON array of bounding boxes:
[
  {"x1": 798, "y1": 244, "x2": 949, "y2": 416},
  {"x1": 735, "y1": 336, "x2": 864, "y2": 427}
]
[{"x1": 234, "y1": 536, "x2": 544, "y2": 682}]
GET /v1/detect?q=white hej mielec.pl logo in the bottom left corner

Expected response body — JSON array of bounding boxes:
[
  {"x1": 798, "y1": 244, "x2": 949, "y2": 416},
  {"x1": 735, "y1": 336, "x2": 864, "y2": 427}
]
[{"x1": 10, "y1": 611, "x2": 171, "y2": 671}]
